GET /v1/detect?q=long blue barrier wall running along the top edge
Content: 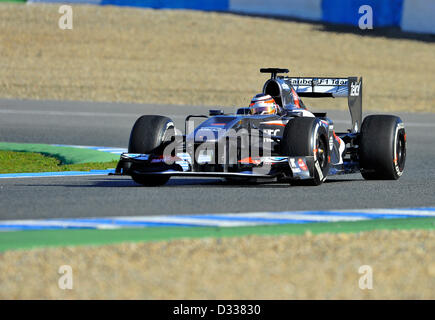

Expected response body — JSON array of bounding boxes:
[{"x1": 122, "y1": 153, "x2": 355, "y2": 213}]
[{"x1": 26, "y1": 0, "x2": 435, "y2": 34}]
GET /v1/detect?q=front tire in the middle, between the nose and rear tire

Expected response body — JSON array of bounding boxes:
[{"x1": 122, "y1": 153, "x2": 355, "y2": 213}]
[{"x1": 281, "y1": 118, "x2": 329, "y2": 186}]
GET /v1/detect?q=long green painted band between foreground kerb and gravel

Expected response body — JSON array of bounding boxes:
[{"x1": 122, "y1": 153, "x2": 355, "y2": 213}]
[{"x1": 0, "y1": 218, "x2": 435, "y2": 251}]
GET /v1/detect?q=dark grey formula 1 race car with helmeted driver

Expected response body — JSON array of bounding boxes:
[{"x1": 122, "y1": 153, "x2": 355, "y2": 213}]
[{"x1": 115, "y1": 68, "x2": 406, "y2": 186}]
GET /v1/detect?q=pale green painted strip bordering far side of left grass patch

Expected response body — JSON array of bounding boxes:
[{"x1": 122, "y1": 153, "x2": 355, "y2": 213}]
[{"x1": 0, "y1": 142, "x2": 119, "y2": 164}]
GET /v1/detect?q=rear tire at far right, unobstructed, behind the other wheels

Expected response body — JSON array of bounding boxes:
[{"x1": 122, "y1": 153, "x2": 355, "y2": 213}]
[{"x1": 359, "y1": 115, "x2": 406, "y2": 180}]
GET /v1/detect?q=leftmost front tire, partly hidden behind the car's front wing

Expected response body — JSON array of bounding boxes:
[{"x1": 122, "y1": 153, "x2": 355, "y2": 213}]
[{"x1": 128, "y1": 115, "x2": 175, "y2": 186}]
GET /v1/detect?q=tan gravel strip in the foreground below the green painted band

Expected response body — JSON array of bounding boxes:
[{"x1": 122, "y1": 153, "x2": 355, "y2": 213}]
[{"x1": 0, "y1": 230, "x2": 435, "y2": 299}]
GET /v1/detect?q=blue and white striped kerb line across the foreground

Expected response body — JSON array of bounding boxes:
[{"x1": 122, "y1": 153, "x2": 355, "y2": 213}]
[{"x1": 0, "y1": 208, "x2": 435, "y2": 231}]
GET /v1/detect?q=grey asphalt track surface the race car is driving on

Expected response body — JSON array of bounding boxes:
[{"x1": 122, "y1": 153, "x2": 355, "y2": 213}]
[{"x1": 0, "y1": 100, "x2": 435, "y2": 220}]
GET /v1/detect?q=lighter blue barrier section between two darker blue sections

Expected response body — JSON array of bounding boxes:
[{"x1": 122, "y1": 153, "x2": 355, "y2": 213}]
[{"x1": 229, "y1": 0, "x2": 322, "y2": 21}]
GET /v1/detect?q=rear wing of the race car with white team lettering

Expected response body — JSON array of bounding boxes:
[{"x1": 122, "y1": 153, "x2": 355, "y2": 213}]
[{"x1": 282, "y1": 77, "x2": 362, "y2": 133}]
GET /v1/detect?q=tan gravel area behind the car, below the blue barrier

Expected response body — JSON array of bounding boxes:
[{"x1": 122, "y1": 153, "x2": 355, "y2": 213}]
[{"x1": 0, "y1": 3, "x2": 435, "y2": 112}]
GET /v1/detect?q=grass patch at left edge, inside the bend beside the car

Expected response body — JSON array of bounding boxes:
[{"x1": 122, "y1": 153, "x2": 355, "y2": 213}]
[{"x1": 0, "y1": 151, "x2": 117, "y2": 173}]
